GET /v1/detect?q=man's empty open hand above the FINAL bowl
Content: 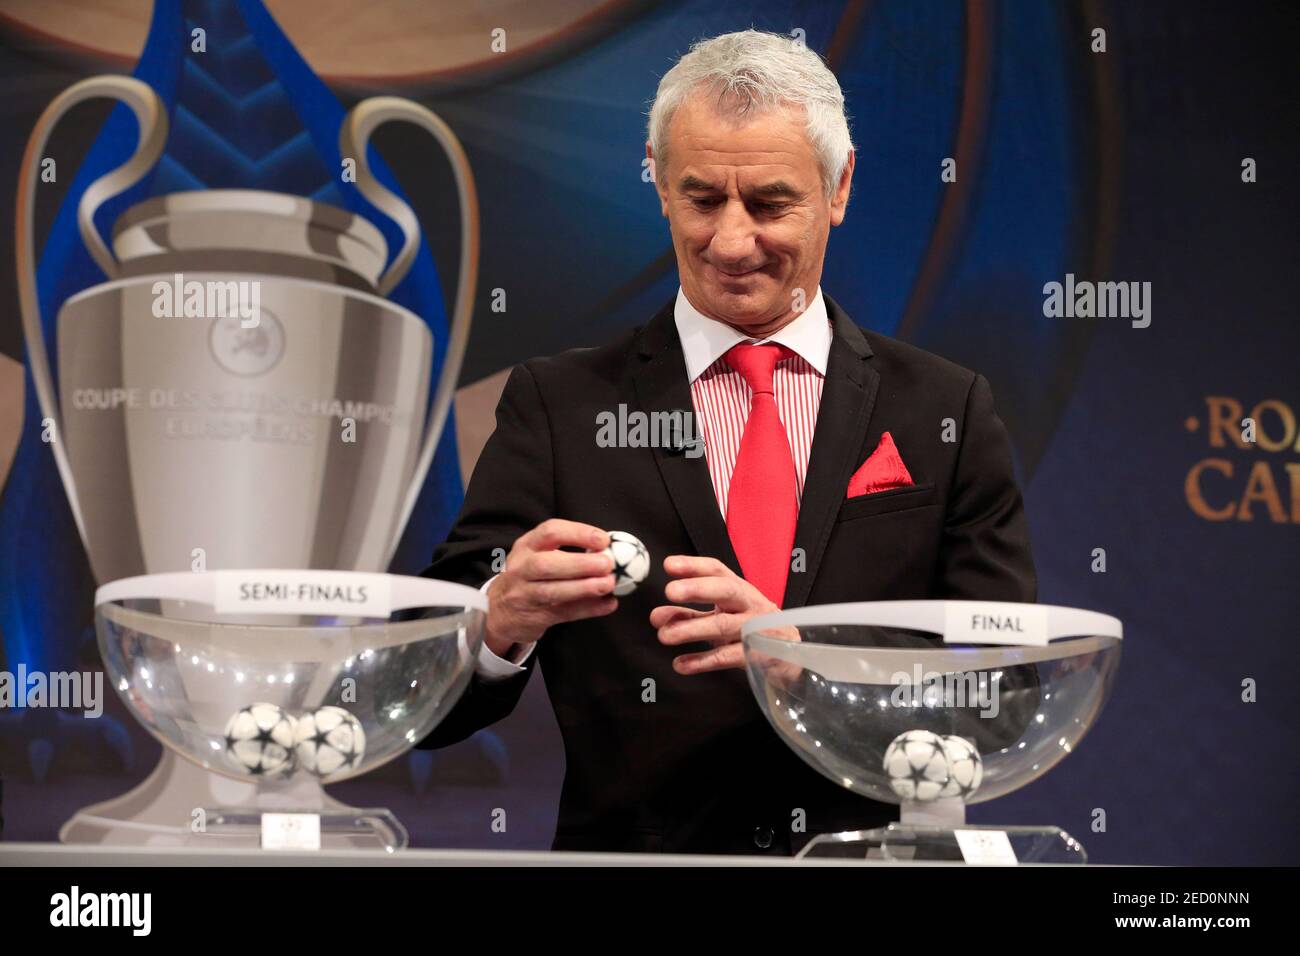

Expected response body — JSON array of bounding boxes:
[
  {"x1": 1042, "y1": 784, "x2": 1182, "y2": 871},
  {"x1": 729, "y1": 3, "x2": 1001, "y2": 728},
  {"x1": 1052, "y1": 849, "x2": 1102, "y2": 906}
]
[{"x1": 650, "y1": 554, "x2": 780, "y2": 674}]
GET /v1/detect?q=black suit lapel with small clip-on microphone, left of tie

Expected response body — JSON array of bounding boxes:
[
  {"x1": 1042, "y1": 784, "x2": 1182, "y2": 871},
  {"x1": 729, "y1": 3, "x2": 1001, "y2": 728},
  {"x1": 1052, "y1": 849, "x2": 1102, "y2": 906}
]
[{"x1": 632, "y1": 303, "x2": 743, "y2": 575}]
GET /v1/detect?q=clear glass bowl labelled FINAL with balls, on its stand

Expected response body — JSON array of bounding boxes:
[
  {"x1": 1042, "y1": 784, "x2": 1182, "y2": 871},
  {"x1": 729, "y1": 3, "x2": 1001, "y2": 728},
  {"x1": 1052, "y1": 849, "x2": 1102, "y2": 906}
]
[{"x1": 741, "y1": 601, "x2": 1123, "y2": 865}]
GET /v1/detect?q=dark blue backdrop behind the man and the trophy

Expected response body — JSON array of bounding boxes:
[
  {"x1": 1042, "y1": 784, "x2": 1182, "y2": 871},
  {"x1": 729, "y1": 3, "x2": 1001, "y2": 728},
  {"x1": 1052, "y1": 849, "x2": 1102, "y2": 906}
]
[{"x1": 0, "y1": 0, "x2": 1300, "y2": 864}]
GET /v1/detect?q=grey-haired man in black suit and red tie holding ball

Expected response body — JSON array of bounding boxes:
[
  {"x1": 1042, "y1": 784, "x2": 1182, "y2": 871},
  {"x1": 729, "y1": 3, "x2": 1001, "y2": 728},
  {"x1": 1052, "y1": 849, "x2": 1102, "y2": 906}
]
[{"x1": 420, "y1": 30, "x2": 1036, "y2": 855}]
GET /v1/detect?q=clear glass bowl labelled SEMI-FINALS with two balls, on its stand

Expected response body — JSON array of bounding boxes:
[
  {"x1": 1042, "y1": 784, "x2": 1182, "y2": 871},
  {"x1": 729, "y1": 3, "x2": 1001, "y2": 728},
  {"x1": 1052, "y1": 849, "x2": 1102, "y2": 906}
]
[{"x1": 82, "y1": 570, "x2": 488, "y2": 849}]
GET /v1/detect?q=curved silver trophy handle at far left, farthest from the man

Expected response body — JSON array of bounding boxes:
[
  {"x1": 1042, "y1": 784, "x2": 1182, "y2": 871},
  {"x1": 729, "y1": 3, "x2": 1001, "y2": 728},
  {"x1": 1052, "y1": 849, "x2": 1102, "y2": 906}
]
[{"x1": 13, "y1": 75, "x2": 168, "y2": 544}]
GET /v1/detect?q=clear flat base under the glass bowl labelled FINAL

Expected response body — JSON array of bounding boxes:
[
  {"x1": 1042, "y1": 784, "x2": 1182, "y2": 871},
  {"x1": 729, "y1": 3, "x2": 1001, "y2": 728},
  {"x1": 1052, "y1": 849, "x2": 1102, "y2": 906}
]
[{"x1": 796, "y1": 822, "x2": 1088, "y2": 866}]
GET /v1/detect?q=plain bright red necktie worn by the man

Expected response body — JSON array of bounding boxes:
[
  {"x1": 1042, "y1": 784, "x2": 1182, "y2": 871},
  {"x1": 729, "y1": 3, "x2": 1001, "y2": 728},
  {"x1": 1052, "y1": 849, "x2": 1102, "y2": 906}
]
[{"x1": 724, "y1": 345, "x2": 800, "y2": 607}]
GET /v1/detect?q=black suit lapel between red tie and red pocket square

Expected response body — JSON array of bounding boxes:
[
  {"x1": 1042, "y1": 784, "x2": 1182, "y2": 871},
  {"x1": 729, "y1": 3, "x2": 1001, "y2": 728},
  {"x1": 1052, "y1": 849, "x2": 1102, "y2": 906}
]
[{"x1": 780, "y1": 293, "x2": 880, "y2": 607}]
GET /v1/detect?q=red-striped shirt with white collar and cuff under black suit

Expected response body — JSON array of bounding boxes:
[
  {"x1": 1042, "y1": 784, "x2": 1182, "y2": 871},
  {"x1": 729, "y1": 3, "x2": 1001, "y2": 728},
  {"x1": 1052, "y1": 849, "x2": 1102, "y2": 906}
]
[{"x1": 476, "y1": 287, "x2": 831, "y2": 680}]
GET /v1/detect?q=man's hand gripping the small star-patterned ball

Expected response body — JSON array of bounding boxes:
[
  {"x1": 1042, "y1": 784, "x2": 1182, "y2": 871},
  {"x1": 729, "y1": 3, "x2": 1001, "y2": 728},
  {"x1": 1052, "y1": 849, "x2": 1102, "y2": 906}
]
[{"x1": 484, "y1": 518, "x2": 619, "y2": 657}]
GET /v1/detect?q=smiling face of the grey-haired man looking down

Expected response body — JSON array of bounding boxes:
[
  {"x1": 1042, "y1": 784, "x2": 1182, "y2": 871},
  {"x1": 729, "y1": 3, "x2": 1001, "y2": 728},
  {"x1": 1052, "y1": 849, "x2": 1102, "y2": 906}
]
[{"x1": 646, "y1": 94, "x2": 853, "y2": 337}]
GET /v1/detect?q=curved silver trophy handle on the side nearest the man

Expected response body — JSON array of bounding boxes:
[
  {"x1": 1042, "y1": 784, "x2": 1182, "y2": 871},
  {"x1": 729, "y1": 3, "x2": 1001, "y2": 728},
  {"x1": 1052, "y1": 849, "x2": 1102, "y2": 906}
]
[{"x1": 338, "y1": 96, "x2": 478, "y2": 566}]
